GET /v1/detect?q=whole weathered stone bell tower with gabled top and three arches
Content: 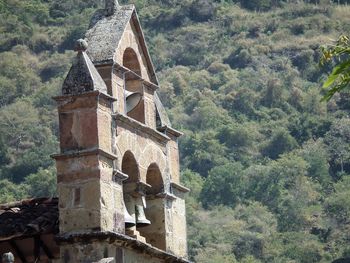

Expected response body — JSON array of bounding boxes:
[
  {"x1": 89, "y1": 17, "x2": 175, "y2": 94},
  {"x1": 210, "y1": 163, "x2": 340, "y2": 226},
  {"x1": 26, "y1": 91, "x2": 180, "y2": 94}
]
[{"x1": 54, "y1": 0, "x2": 188, "y2": 262}]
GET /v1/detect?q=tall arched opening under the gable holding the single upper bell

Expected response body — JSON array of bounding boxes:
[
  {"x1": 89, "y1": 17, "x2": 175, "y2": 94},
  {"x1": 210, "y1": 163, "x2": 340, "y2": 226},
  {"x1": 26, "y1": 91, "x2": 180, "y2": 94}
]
[{"x1": 123, "y1": 48, "x2": 145, "y2": 123}]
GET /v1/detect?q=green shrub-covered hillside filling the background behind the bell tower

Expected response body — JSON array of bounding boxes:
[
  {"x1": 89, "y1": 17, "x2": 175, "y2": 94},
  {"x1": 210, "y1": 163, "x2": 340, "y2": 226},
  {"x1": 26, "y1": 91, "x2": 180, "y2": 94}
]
[{"x1": 0, "y1": 0, "x2": 350, "y2": 263}]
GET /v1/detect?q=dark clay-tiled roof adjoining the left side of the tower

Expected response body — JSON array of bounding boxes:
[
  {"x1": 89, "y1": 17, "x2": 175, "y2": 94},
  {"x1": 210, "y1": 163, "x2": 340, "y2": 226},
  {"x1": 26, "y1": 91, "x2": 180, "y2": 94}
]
[{"x1": 0, "y1": 198, "x2": 58, "y2": 241}]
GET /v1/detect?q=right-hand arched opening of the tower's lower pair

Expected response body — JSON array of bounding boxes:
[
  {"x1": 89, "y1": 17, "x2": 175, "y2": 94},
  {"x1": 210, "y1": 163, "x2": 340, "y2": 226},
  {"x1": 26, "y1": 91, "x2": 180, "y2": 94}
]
[{"x1": 139, "y1": 163, "x2": 166, "y2": 250}]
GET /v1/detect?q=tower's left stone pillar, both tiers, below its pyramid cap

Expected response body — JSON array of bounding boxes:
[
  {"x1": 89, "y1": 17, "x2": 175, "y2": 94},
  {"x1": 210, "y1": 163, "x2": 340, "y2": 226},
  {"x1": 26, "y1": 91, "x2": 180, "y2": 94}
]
[{"x1": 56, "y1": 92, "x2": 124, "y2": 233}]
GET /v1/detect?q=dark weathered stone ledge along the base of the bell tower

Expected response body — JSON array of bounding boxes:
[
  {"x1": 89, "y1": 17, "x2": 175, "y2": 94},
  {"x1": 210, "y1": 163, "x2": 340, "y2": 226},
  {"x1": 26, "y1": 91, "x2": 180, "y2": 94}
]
[{"x1": 55, "y1": 231, "x2": 190, "y2": 263}]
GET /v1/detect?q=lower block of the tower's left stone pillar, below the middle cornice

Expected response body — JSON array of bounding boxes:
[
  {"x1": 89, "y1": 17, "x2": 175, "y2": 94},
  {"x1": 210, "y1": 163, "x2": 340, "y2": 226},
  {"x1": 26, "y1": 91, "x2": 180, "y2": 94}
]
[{"x1": 57, "y1": 154, "x2": 124, "y2": 233}]
